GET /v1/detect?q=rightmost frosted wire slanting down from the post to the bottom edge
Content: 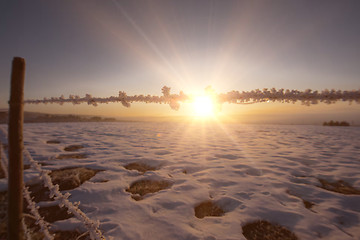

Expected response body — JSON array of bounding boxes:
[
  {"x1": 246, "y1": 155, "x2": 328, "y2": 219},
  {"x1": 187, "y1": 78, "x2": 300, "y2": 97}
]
[{"x1": 24, "y1": 149, "x2": 105, "y2": 240}]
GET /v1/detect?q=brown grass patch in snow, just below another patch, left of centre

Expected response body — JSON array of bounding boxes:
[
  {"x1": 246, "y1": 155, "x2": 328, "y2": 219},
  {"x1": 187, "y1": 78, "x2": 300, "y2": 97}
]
[{"x1": 126, "y1": 180, "x2": 172, "y2": 201}]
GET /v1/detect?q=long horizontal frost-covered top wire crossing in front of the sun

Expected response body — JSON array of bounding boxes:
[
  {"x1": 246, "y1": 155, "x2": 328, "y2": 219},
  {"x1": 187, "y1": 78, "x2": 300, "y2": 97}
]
[{"x1": 24, "y1": 86, "x2": 360, "y2": 110}]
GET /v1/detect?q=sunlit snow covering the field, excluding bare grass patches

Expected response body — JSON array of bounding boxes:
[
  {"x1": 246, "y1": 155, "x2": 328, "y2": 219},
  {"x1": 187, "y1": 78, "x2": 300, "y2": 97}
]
[{"x1": 0, "y1": 122, "x2": 360, "y2": 240}]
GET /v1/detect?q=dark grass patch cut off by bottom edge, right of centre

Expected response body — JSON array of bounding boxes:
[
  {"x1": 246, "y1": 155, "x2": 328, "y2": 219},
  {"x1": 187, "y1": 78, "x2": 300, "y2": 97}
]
[{"x1": 242, "y1": 220, "x2": 298, "y2": 240}]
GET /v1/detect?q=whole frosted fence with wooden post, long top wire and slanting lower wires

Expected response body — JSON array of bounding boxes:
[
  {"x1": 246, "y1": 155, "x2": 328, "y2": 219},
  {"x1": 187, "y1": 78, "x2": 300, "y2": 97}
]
[{"x1": 0, "y1": 57, "x2": 360, "y2": 240}]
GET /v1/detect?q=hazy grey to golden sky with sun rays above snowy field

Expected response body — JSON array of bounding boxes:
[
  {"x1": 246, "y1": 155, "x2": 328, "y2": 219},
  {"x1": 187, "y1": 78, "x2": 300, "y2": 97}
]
[{"x1": 0, "y1": 0, "x2": 360, "y2": 124}]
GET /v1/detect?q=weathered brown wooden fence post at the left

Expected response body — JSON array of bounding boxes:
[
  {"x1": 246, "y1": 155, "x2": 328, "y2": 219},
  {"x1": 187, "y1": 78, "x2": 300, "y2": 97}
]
[{"x1": 8, "y1": 57, "x2": 25, "y2": 240}]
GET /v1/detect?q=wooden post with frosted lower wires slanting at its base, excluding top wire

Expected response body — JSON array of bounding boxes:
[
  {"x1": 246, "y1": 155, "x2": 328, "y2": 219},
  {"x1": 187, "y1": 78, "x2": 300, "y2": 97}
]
[{"x1": 0, "y1": 57, "x2": 105, "y2": 240}]
